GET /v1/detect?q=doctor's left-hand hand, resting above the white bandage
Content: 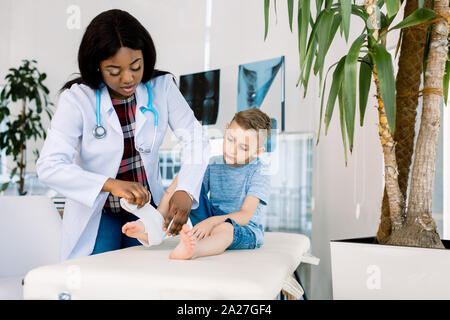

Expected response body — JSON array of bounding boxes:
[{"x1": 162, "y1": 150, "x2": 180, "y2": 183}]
[{"x1": 102, "y1": 178, "x2": 150, "y2": 209}]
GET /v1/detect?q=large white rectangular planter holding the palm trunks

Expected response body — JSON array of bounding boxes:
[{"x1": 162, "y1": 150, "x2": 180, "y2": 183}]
[{"x1": 330, "y1": 237, "x2": 450, "y2": 299}]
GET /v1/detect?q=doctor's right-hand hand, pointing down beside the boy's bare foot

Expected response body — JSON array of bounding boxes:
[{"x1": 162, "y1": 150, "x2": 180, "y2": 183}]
[{"x1": 163, "y1": 190, "x2": 192, "y2": 236}]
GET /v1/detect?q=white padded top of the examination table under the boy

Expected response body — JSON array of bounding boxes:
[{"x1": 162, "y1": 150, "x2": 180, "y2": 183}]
[{"x1": 23, "y1": 232, "x2": 310, "y2": 300}]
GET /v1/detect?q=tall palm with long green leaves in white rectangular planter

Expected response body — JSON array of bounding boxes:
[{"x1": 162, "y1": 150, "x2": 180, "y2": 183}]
[{"x1": 264, "y1": 0, "x2": 450, "y2": 299}]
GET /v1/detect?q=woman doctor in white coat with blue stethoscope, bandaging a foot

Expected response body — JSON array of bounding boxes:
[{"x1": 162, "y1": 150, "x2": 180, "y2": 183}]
[{"x1": 36, "y1": 9, "x2": 209, "y2": 260}]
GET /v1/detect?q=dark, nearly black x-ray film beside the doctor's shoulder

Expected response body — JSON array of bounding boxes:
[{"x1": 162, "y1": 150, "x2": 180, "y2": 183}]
[{"x1": 180, "y1": 70, "x2": 220, "y2": 125}]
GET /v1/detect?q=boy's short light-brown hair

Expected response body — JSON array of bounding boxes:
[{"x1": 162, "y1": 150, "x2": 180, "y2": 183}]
[{"x1": 230, "y1": 107, "x2": 272, "y2": 147}]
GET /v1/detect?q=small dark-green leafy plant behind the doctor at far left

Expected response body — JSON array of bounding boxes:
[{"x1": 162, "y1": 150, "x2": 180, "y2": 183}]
[{"x1": 0, "y1": 60, "x2": 53, "y2": 195}]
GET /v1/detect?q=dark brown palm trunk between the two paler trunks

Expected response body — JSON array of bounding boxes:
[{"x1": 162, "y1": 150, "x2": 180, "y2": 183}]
[{"x1": 377, "y1": 0, "x2": 431, "y2": 243}]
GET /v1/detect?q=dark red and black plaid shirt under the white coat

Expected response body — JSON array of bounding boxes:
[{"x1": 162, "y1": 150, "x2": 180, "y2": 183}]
[{"x1": 104, "y1": 94, "x2": 156, "y2": 213}]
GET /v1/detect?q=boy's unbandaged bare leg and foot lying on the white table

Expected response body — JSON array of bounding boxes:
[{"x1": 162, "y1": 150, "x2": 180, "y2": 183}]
[{"x1": 169, "y1": 222, "x2": 233, "y2": 260}]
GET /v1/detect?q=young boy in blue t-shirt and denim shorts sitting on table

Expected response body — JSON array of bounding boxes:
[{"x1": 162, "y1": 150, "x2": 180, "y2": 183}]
[{"x1": 122, "y1": 108, "x2": 271, "y2": 260}]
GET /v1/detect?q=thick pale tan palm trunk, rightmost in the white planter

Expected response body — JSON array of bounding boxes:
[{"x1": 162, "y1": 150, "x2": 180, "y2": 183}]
[{"x1": 388, "y1": 0, "x2": 449, "y2": 248}]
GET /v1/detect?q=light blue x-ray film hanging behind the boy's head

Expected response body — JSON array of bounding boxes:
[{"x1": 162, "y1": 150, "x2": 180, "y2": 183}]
[{"x1": 237, "y1": 57, "x2": 285, "y2": 152}]
